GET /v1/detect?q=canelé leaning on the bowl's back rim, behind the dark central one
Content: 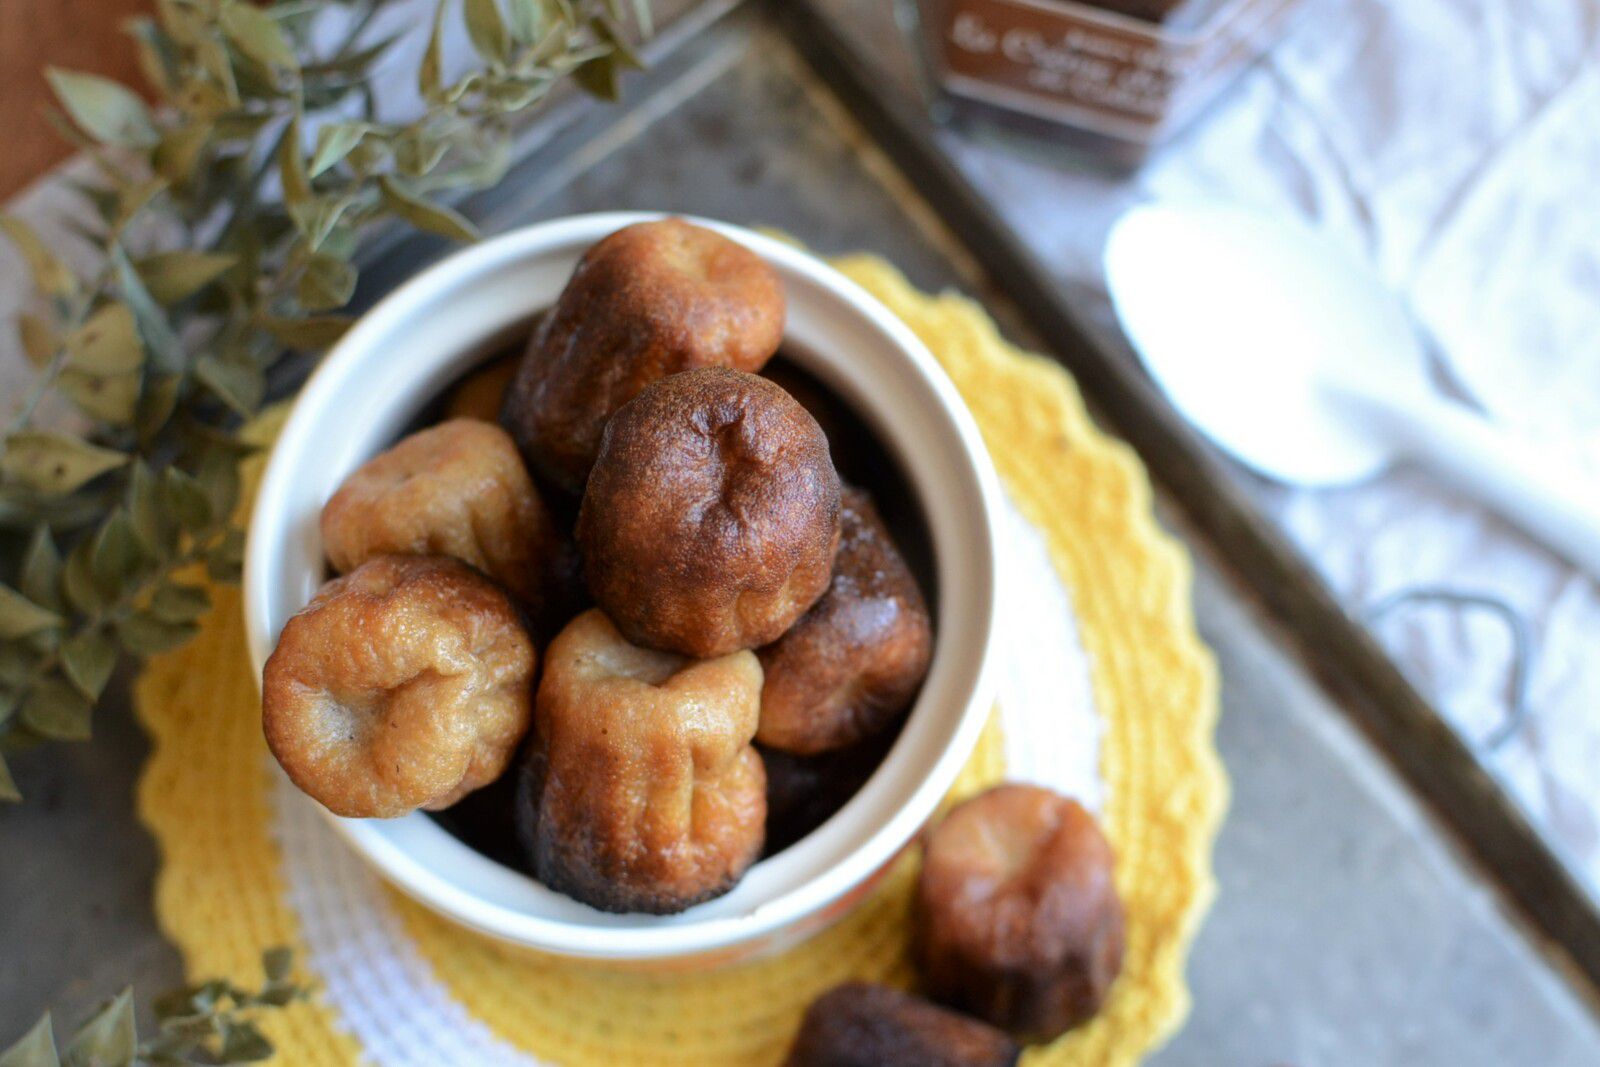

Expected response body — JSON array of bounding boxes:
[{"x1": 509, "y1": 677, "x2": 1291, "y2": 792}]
[{"x1": 502, "y1": 219, "x2": 784, "y2": 493}]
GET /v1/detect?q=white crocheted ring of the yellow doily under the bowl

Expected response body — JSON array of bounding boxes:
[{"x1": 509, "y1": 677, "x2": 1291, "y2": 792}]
[{"x1": 269, "y1": 495, "x2": 1104, "y2": 1067}]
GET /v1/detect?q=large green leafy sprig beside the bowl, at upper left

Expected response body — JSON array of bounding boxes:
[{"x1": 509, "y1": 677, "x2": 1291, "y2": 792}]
[{"x1": 0, "y1": 0, "x2": 648, "y2": 800}]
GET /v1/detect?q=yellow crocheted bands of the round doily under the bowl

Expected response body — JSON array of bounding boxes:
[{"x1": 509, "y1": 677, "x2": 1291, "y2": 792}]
[{"x1": 136, "y1": 256, "x2": 1227, "y2": 1067}]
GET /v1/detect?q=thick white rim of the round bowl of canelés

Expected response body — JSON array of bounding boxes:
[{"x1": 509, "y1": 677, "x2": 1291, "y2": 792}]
[{"x1": 243, "y1": 211, "x2": 1003, "y2": 961}]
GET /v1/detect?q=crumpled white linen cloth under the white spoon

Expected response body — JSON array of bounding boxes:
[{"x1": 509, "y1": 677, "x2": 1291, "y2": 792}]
[{"x1": 946, "y1": 0, "x2": 1600, "y2": 891}]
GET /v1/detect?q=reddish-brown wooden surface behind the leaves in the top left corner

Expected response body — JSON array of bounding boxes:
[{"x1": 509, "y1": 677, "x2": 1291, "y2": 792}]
[{"x1": 0, "y1": 0, "x2": 150, "y2": 200}]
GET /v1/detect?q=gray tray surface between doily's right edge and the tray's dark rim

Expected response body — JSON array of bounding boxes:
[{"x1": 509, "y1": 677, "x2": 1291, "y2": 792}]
[{"x1": 1152, "y1": 565, "x2": 1600, "y2": 1067}]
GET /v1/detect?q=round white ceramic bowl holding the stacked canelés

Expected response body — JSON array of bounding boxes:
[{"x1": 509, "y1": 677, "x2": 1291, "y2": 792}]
[{"x1": 245, "y1": 213, "x2": 1000, "y2": 966}]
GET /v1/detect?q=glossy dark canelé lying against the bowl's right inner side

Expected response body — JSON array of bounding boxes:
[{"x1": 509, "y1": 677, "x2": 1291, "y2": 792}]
[{"x1": 755, "y1": 488, "x2": 933, "y2": 755}]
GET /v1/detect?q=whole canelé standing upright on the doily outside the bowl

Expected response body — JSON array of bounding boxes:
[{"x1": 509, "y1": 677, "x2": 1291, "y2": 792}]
[{"x1": 915, "y1": 784, "x2": 1123, "y2": 1041}]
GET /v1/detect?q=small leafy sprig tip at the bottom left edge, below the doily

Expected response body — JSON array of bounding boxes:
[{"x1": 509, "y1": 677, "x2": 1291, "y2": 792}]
[{"x1": 0, "y1": 949, "x2": 307, "y2": 1067}]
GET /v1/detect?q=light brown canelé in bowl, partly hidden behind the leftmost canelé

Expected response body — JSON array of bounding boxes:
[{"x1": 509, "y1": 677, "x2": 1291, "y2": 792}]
[{"x1": 322, "y1": 419, "x2": 563, "y2": 614}]
